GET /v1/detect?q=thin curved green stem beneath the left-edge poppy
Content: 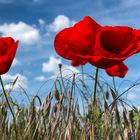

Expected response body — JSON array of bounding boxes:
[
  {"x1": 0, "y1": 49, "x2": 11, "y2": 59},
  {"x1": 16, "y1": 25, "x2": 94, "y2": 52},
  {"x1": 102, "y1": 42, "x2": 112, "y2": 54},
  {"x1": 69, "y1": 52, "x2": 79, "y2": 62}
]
[{"x1": 0, "y1": 75, "x2": 17, "y2": 140}]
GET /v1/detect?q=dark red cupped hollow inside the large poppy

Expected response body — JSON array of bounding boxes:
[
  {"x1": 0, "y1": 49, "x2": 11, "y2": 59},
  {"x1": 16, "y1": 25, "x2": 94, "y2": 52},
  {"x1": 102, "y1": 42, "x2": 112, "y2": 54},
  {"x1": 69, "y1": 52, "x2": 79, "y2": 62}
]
[{"x1": 100, "y1": 27, "x2": 133, "y2": 54}]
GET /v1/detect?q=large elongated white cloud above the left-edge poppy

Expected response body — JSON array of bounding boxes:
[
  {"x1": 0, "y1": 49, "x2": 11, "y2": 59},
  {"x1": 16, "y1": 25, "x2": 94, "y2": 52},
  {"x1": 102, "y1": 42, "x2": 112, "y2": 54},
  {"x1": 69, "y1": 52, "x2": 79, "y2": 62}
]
[{"x1": 0, "y1": 21, "x2": 40, "y2": 45}]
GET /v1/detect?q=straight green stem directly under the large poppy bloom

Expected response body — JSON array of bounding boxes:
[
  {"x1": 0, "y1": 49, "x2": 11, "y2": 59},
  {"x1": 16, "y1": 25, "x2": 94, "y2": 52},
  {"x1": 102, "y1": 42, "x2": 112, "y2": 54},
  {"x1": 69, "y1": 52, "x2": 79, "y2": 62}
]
[{"x1": 93, "y1": 67, "x2": 99, "y2": 106}]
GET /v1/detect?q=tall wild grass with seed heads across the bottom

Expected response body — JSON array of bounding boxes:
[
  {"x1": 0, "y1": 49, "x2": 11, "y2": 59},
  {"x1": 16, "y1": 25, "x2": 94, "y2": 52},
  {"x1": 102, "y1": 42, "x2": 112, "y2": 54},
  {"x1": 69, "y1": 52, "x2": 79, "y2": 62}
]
[{"x1": 0, "y1": 65, "x2": 140, "y2": 140}]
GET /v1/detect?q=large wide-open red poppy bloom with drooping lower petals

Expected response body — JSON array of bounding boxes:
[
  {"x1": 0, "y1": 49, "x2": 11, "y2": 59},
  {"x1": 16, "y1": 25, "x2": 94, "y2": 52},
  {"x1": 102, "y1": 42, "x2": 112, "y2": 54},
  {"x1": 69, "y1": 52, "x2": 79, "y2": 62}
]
[{"x1": 54, "y1": 16, "x2": 140, "y2": 77}]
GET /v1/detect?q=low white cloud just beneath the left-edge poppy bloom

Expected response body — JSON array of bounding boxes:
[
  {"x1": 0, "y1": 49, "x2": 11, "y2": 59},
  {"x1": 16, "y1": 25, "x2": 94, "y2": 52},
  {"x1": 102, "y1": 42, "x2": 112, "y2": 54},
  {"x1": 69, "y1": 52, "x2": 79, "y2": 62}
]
[{"x1": 2, "y1": 73, "x2": 27, "y2": 90}]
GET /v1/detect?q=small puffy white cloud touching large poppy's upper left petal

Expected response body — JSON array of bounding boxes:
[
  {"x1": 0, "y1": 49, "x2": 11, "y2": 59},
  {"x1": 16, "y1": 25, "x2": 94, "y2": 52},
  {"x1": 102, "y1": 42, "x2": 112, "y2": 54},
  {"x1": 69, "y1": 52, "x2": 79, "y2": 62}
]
[{"x1": 49, "y1": 15, "x2": 75, "y2": 32}]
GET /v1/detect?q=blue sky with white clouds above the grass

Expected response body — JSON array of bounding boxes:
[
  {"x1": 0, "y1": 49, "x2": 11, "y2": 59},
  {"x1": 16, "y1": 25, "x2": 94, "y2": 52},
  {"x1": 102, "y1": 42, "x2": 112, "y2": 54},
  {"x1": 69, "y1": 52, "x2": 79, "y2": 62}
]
[{"x1": 0, "y1": 0, "x2": 140, "y2": 106}]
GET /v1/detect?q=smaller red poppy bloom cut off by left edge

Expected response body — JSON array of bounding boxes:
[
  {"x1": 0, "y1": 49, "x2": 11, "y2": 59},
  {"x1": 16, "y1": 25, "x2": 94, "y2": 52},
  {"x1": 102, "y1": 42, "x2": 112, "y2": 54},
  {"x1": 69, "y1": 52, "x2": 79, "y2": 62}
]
[{"x1": 0, "y1": 37, "x2": 18, "y2": 74}]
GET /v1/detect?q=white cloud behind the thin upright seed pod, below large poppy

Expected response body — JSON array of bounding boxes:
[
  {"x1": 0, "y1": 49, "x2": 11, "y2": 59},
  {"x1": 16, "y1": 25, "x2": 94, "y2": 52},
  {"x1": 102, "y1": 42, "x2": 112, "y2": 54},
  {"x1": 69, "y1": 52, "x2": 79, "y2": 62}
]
[{"x1": 42, "y1": 56, "x2": 80, "y2": 77}]
